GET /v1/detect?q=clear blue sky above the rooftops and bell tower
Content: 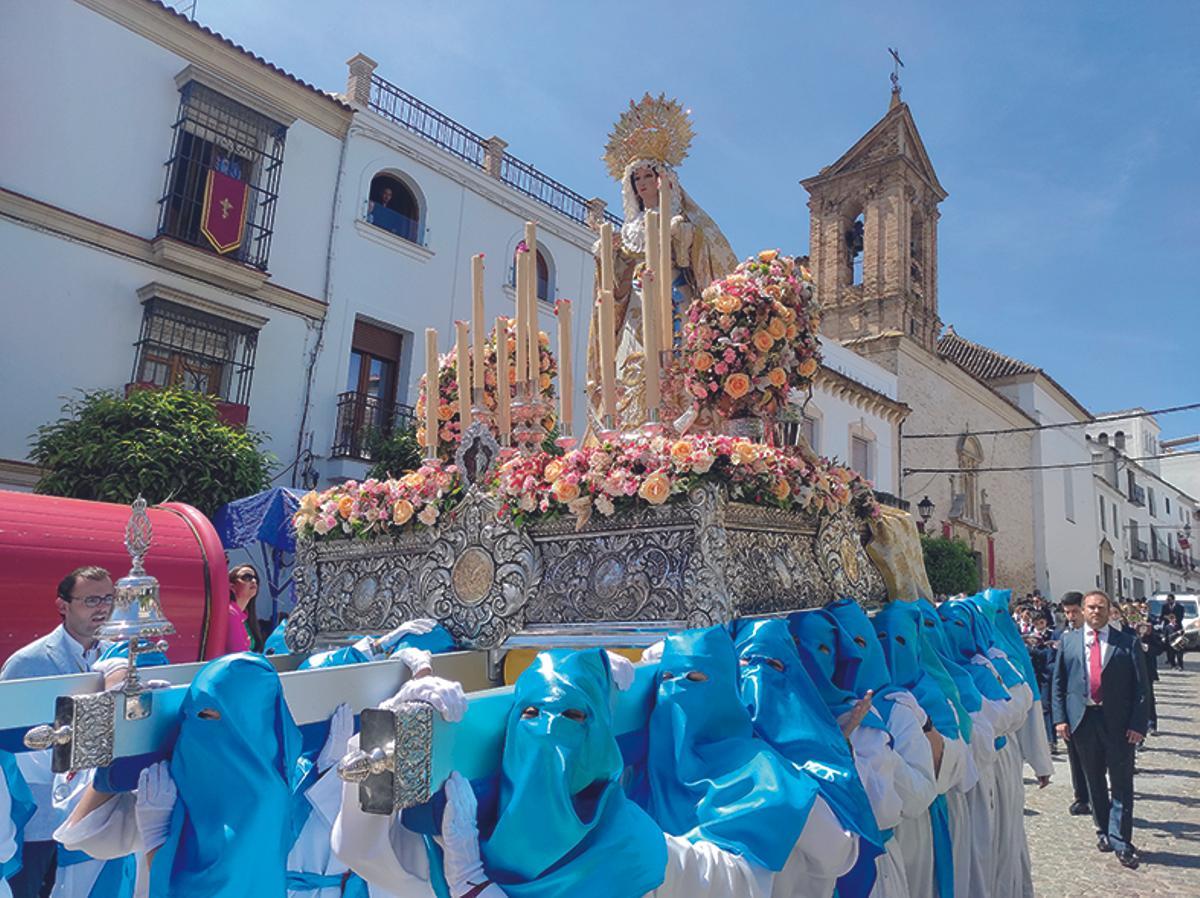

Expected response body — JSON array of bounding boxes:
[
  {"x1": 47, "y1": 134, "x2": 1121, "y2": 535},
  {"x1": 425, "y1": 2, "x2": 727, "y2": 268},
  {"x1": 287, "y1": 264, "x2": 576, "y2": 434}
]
[{"x1": 182, "y1": 0, "x2": 1200, "y2": 437}]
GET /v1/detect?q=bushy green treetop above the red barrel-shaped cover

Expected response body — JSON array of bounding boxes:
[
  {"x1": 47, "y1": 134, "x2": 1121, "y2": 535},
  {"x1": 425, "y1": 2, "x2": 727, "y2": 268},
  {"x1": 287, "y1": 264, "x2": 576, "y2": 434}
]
[{"x1": 30, "y1": 389, "x2": 274, "y2": 516}]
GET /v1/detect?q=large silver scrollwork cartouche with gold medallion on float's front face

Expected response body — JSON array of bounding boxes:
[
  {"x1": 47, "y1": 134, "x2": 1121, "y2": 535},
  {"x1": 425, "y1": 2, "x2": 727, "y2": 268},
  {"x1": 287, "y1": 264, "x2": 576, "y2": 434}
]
[{"x1": 416, "y1": 487, "x2": 540, "y2": 648}]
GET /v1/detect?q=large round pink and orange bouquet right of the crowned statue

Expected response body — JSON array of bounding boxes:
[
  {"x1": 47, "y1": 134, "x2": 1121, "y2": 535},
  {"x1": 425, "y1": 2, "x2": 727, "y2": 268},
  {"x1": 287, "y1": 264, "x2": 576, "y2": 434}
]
[{"x1": 683, "y1": 250, "x2": 821, "y2": 419}]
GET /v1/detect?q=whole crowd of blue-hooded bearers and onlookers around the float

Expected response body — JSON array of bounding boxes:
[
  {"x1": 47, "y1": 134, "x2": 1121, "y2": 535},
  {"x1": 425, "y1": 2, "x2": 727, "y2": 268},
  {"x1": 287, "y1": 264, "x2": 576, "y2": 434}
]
[{"x1": 0, "y1": 565, "x2": 1174, "y2": 898}]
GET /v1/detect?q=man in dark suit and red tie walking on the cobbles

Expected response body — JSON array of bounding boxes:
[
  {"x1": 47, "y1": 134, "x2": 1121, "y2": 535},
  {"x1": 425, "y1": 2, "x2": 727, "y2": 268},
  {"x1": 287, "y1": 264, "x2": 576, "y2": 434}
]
[{"x1": 1054, "y1": 591, "x2": 1146, "y2": 869}]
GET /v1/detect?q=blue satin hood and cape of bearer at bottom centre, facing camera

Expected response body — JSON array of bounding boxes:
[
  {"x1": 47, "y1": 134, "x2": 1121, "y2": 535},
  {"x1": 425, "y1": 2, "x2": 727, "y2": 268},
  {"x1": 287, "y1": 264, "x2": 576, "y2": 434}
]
[{"x1": 480, "y1": 648, "x2": 667, "y2": 898}]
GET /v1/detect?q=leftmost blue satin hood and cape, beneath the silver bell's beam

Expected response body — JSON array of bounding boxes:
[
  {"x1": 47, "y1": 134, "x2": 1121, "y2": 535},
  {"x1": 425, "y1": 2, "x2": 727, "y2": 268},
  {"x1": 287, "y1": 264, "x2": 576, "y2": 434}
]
[{"x1": 150, "y1": 652, "x2": 301, "y2": 898}]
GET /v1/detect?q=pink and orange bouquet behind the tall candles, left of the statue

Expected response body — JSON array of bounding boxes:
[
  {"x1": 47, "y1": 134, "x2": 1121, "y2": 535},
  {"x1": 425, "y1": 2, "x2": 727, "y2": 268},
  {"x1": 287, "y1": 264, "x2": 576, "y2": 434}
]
[{"x1": 415, "y1": 321, "x2": 558, "y2": 459}]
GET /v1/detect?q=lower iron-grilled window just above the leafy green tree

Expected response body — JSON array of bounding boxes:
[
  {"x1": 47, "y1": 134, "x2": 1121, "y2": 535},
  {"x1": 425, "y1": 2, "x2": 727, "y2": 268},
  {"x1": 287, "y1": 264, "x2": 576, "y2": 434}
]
[{"x1": 133, "y1": 299, "x2": 258, "y2": 406}]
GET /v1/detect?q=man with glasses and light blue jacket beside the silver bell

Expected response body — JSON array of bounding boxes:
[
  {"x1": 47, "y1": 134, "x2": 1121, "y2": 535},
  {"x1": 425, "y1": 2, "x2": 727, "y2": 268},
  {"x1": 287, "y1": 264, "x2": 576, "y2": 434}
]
[{"x1": 0, "y1": 565, "x2": 113, "y2": 898}]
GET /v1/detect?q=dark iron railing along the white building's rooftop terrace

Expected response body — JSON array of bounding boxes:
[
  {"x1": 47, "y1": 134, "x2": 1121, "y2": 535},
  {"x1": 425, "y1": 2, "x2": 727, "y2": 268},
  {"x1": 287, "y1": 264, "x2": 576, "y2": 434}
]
[{"x1": 368, "y1": 76, "x2": 622, "y2": 228}]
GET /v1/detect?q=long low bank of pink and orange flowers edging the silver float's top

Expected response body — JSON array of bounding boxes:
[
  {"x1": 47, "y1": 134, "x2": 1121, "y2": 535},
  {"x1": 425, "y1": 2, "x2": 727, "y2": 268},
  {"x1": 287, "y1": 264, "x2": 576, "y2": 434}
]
[{"x1": 293, "y1": 433, "x2": 880, "y2": 538}]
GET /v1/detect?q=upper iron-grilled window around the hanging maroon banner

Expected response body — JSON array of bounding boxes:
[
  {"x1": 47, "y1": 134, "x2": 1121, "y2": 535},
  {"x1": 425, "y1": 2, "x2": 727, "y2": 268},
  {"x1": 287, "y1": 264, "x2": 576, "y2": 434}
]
[{"x1": 158, "y1": 82, "x2": 288, "y2": 271}]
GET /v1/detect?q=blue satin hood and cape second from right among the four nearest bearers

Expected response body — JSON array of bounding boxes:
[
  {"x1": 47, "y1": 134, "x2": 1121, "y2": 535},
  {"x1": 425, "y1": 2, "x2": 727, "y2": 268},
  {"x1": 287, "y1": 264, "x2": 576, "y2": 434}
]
[{"x1": 646, "y1": 627, "x2": 817, "y2": 872}]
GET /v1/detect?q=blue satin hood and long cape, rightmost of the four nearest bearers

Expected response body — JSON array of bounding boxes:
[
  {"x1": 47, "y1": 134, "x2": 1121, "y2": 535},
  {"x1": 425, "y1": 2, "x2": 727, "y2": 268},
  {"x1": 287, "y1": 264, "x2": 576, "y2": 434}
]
[{"x1": 734, "y1": 618, "x2": 883, "y2": 898}]
